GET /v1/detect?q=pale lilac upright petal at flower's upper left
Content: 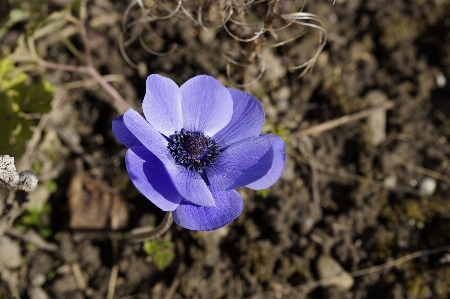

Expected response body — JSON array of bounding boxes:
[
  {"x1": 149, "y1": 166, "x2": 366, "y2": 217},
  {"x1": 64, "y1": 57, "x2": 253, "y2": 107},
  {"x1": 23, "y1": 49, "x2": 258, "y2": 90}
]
[{"x1": 142, "y1": 75, "x2": 183, "y2": 136}]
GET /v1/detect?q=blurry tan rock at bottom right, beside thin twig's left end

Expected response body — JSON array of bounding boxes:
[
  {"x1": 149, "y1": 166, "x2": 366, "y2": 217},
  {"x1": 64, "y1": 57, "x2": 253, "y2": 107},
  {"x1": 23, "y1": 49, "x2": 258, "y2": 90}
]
[{"x1": 317, "y1": 254, "x2": 354, "y2": 291}]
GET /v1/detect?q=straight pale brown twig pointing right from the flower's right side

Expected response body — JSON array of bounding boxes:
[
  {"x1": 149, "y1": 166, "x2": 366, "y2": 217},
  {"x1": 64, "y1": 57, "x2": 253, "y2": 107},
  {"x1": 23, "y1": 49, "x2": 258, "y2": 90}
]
[{"x1": 292, "y1": 101, "x2": 395, "y2": 138}]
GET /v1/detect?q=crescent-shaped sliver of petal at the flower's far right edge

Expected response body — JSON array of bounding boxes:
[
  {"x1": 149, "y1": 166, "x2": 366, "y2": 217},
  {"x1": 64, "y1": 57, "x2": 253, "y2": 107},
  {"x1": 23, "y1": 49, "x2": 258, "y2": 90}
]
[{"x1": 246, "y1": 134, "x2": 286, "y2": 190}]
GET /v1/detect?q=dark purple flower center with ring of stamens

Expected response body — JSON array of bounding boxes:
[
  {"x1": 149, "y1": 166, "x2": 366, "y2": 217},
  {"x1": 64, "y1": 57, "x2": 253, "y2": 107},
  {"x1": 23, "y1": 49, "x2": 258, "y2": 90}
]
[{"x1": 167, "y1": 129, "x2": 219, "y2": 172}]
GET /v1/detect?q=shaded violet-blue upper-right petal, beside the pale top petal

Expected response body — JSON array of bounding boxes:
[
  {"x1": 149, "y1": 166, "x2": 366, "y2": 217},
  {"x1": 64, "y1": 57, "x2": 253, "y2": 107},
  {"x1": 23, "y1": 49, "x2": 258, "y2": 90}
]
[{"x1": 214, "y1": 88, "x2": 264, "y2": 146}]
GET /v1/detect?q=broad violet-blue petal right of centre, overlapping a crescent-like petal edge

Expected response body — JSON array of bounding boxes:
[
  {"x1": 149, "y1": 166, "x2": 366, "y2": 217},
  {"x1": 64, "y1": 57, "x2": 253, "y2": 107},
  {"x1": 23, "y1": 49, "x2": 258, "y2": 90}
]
[{"x1": 206, "y1": 135, "x2": 274, "y2": 190}]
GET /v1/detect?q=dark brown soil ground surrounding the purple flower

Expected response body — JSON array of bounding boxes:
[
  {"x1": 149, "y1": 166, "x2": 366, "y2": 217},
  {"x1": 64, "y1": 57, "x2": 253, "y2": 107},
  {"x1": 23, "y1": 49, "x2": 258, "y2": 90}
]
[{"x1": 0, "y1": 0, "x2": 450, "y2": 299}]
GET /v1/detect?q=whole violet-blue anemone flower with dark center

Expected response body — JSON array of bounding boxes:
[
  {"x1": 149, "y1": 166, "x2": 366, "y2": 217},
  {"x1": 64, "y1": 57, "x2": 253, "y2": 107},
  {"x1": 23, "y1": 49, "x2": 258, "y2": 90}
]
[{"x1": 112, "y1": 75, "x2": 286, "y2": 231}]
